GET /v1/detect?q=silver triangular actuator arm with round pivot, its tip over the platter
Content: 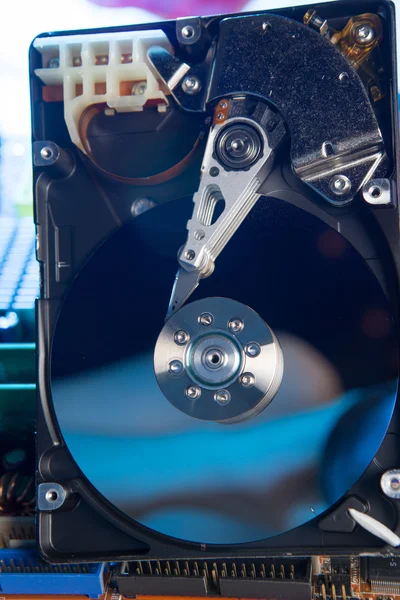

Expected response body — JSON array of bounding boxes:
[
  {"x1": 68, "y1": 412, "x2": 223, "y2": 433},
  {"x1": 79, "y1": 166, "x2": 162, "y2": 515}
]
[{"x1": 167, "y1": 101, "x2": 285, "y2": 319}]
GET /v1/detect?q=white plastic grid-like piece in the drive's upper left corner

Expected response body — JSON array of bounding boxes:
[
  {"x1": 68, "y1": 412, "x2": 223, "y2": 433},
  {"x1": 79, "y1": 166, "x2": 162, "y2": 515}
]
[{"x1": 33, "y1": 29, "x2": 173, "y2": 152}]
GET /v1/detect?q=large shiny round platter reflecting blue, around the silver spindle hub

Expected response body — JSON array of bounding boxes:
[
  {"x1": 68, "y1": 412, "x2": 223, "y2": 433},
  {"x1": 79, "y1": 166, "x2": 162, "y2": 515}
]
[{"x1": 51, "y1": 197, "x2": 398, "y2": 544}]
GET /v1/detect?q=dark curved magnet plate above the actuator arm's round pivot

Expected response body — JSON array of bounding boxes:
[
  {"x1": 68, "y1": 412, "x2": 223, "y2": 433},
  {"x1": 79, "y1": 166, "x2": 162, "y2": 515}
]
[{"x1": 148, "y1": 15, "x2": 387, "y2": 206}]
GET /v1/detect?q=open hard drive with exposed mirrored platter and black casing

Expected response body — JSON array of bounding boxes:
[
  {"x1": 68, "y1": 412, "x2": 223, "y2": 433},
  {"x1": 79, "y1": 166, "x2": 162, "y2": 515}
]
[{"x1": 30, "y1": 0, "x2": 400, "y2": 598}]
